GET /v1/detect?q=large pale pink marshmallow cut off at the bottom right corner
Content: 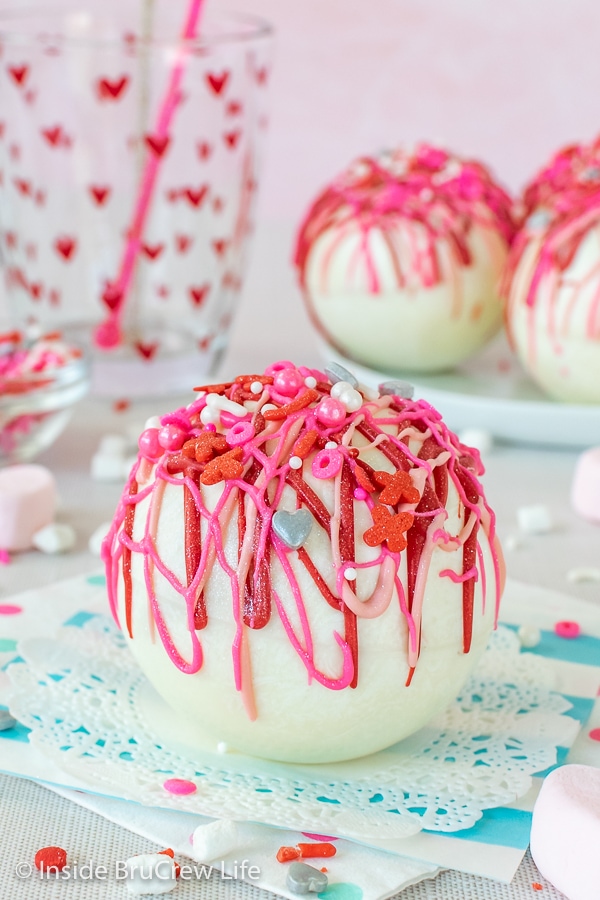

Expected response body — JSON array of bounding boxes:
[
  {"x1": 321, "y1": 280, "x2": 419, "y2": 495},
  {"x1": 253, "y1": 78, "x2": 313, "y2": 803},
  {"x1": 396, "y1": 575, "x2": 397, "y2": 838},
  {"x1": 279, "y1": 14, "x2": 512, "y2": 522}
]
[{"x1": 531, "y1": 765, "x2": 600, "y2": 900}]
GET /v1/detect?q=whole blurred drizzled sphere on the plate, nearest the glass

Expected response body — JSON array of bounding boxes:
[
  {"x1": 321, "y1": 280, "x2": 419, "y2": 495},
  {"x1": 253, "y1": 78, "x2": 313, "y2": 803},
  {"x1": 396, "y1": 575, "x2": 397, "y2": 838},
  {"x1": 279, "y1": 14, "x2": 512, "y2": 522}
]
[{"x1": 296, "y1": 147, "x2": 513, "y2": 372}]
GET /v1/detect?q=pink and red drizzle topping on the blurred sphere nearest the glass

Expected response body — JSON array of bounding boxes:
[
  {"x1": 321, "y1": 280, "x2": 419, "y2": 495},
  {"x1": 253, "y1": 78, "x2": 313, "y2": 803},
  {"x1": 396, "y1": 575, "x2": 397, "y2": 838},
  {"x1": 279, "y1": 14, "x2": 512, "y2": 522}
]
[{"x1": 294, "y1": 144, "x2": 515, "y2": 348}]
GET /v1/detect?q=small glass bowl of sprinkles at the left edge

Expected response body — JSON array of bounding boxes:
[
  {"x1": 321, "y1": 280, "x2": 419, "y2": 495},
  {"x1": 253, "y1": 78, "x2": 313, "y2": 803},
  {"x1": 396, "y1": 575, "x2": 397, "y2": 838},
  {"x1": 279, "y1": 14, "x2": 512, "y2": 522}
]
[{"x1": 0, "y1": 356, "x2": 90, "y2": 466}]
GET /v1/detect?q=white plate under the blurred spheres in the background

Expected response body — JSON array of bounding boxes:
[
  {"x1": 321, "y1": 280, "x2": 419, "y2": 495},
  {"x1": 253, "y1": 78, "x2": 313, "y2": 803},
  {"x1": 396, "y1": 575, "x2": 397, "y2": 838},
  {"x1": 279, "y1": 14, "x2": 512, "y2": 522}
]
[{"x1": 319, "y1": 336, "x2": 600, "y2": 447}]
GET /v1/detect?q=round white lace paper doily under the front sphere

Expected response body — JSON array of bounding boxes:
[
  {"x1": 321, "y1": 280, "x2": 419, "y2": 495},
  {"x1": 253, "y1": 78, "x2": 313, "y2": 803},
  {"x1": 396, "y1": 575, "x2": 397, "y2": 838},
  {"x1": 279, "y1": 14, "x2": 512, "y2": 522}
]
[{"x1": 8, "y1": 616, "x2": 579, "y2": 842}]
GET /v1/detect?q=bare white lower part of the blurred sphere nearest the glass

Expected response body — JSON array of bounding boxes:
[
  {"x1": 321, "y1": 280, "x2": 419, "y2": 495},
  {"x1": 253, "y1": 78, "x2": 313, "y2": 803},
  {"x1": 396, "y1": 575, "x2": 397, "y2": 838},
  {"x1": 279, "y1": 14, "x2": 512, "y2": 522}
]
[{"x1": 304, "y1": 221, "x2": 507, "y2": 372}]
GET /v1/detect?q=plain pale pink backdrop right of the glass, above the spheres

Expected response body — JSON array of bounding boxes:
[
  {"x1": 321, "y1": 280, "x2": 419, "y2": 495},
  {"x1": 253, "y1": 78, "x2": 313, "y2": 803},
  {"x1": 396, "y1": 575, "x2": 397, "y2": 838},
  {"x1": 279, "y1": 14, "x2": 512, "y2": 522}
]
[{"x1": 229, "y1": 0, "x2": 600, "y2": 223}]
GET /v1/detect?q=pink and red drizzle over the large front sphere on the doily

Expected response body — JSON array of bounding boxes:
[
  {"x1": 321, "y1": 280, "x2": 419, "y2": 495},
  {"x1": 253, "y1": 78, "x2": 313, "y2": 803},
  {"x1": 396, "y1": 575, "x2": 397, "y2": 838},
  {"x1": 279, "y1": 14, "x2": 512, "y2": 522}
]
[{"x1": 103, "y1": 362, "x2": 502, "y2": 718}]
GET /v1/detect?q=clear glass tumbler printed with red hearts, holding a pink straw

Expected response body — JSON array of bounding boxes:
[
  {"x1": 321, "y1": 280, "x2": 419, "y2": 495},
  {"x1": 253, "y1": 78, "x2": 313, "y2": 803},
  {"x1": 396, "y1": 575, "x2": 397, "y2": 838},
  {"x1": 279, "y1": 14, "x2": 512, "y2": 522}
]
[{"x1": 0, "y1": 0, "x2": 271, "y2": 397}]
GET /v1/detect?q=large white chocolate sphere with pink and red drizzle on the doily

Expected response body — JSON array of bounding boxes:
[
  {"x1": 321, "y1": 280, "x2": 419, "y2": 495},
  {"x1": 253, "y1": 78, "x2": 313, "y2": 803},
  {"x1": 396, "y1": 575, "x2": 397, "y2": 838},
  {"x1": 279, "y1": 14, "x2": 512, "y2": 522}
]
[{"x1": 104, "y1": 364, "x2": 501, "y2": 762}]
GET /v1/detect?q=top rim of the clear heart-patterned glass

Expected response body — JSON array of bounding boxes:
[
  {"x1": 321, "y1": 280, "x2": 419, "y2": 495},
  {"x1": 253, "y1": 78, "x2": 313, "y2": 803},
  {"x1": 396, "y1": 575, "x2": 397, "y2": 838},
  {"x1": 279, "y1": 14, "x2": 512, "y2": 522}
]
[{"x1": 0, "y1": 5, "x2": 274, "y2": 50}]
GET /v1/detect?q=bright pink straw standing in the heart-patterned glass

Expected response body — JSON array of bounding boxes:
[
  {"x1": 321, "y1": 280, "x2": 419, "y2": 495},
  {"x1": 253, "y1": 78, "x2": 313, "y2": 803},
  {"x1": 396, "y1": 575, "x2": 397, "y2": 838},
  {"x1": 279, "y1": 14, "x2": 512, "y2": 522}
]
[{"x1": 94, "y1": 0, "x2": 204, "y2": 349}]
